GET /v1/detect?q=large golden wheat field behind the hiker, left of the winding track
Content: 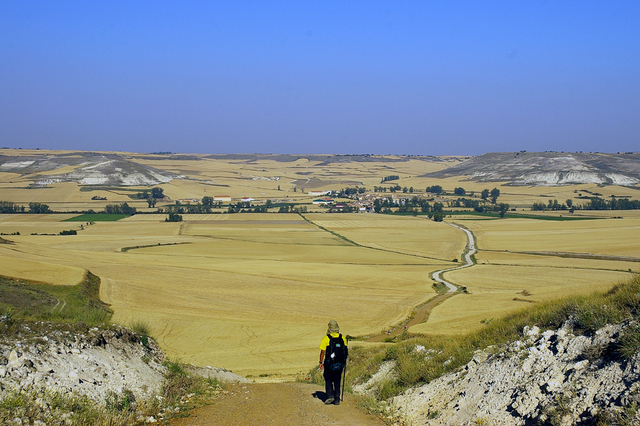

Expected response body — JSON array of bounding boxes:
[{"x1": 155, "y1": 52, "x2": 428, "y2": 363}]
[{"x1": 0, "y1": 214, "x2": 452, "y2": 375}]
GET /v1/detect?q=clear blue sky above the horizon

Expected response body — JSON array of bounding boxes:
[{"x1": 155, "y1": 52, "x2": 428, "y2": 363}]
[{"x1": 0, "y1": 0, "x2": 640, "y2": 155}]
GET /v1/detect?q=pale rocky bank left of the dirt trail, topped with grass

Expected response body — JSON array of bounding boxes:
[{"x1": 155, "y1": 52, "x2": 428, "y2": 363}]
[{"x1": 0, "y1": 322, "x2": 166, "y2": 403}]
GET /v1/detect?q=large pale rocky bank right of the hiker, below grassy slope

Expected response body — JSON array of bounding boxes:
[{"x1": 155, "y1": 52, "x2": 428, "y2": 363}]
[{"x1": 370, "y1": 322, "x2": 640, "y2": 425}]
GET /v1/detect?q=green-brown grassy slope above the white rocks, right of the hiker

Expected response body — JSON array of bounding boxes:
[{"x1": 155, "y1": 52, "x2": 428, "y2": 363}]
[{"x1": 349, "y1": 275, "x2": 640, "y2": 402}]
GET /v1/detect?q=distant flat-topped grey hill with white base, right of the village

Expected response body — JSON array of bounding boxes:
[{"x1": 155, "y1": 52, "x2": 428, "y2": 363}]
[{"x1": 423, "y1": 151, "x2": 640, "y2": 186}]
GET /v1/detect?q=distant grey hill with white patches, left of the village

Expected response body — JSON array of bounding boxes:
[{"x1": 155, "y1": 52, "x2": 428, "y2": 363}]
[{"x1": 0, "y1": 151, "x2": 180, "y2": 186}]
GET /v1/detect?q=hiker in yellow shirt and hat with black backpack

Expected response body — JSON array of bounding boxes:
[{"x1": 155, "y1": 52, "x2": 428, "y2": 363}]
[{"x1": 320, "y1": 320, "x2": 349, "y2": 405}]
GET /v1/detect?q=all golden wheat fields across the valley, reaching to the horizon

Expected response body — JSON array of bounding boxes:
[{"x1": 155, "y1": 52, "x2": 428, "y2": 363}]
[{"x1": 0, "y1": 150, "x2": 640, "y2": 377}]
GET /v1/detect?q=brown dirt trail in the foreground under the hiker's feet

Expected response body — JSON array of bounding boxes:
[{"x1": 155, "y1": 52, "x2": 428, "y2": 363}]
[{"x1": 170, "y1": 383, "x2": 384, "y2": 426}]
